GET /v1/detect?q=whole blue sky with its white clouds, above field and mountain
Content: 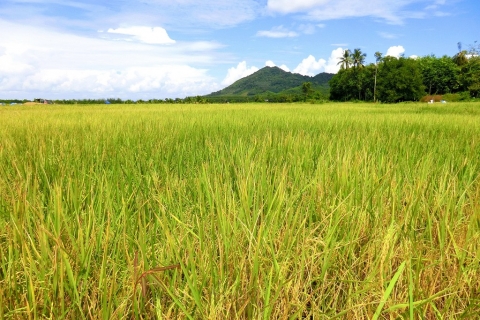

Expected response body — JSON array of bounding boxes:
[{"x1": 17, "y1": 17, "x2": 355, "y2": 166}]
[{"x1": 0, "y1": 0, "x2": 480, "y2": 100}]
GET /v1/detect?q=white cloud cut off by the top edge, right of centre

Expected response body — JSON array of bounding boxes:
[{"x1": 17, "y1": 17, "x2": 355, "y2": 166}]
[{"x1": 267, "y1": 0, "x2": 444, "y2": 24}]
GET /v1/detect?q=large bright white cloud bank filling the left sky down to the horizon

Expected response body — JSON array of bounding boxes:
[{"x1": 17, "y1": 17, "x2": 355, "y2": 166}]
[{"x1": 0, "y1": 19, "x2": 221, "y2": 99}]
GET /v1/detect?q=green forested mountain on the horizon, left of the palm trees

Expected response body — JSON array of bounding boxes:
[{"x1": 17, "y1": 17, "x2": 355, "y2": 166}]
[{"x1": 205, "y1": 67, "x2": 333, "y2": 98}]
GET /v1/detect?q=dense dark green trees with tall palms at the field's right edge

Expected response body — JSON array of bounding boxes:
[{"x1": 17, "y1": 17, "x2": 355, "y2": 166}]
[{"x1": 330, "y1": 43, "x2": 480, "y2": 102}]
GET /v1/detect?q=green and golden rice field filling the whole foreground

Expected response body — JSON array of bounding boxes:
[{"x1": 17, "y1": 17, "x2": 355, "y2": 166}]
[{"x1": 0, "y1": 103, "x2": 480, "y2": 319}]
